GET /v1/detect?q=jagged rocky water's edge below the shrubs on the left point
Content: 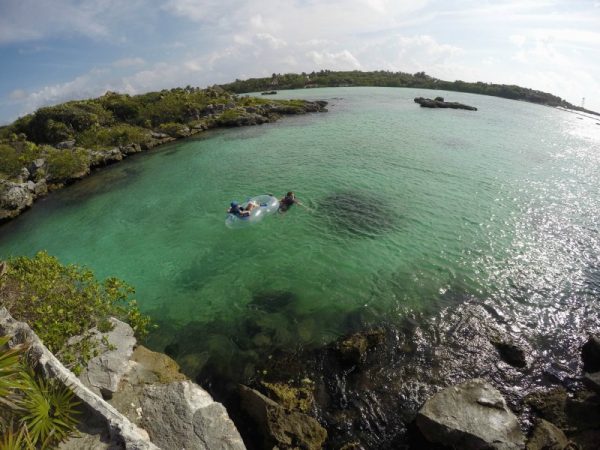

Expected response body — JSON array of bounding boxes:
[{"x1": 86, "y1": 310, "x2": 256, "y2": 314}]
[{"x1": 0, "y1": 101, "x2": 327, "y2": 224}]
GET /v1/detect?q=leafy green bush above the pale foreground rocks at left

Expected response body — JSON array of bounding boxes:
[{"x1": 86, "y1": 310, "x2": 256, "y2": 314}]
[{"x1": 0, "y1": 252, "x2": 151, "y2": 374}]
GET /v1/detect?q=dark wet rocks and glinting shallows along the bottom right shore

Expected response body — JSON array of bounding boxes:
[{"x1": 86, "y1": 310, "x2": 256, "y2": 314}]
[{"x1": 198, "y1": 303, "x2": 600, "y2": 450}]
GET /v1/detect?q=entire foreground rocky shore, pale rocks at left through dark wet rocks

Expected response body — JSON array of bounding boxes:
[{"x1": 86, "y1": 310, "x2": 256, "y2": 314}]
[{"x1": 0, "y1": 284, "x2": 600, "y2": 450}]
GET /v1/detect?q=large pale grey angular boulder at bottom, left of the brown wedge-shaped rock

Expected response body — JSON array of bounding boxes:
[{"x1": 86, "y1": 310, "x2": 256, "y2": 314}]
[{"x1": 141, "y1": 381, "x2": 245, "y2": 450}]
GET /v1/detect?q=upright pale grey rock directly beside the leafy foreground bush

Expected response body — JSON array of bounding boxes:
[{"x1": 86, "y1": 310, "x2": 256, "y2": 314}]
[{"x1": 79, "y1": 318, "x2": 136, "y2": 398}]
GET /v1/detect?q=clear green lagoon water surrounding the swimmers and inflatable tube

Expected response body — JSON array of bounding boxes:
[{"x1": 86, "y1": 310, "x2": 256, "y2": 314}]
[{"x1": 0, "y1": 88, "x2": 600, "y2": 376}]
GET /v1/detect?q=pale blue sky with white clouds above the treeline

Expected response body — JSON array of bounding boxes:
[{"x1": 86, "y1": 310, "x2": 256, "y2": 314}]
[{"x1": 0, "y1": 0, "x2": 600, "y2": 124}]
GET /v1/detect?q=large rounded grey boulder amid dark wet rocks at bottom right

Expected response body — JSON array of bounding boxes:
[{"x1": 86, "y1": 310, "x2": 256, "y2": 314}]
[{"x1": 417, "y1": 379, "x2": 525, "y2": 450}]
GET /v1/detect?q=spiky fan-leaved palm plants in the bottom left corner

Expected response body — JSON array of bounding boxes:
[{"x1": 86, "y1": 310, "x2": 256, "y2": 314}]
[{"x1": 0, "y1": 336, "x2": 79, "y2": 450}]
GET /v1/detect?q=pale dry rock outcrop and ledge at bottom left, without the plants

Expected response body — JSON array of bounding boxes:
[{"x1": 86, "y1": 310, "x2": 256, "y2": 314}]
[{"x1": 0, "y1": 308, "x2": 245, "y2": 450}]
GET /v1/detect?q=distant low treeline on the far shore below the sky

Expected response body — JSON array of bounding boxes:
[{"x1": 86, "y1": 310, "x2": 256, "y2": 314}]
[{"x1": 221, "y1": 70, "x2": 600, "y2": 115}]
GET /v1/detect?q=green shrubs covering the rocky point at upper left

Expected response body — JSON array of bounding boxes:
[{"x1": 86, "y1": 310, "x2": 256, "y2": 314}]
[{"x1": 0, "y1": 86, "x2": 324, "y2": 188}]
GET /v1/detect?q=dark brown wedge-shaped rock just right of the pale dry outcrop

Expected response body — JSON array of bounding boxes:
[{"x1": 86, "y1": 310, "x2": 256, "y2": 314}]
[{"x1": 240, "y1": 386, "x2": 327, "y2": 450}]
